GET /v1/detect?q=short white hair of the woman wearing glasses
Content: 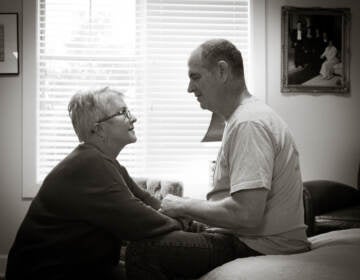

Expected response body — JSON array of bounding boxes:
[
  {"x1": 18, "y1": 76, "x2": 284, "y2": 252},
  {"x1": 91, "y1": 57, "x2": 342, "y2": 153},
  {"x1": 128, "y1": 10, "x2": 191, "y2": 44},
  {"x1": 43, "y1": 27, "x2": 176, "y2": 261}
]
[{"x1": 68, "y1": 87, "x2": 124, "y2": 142}]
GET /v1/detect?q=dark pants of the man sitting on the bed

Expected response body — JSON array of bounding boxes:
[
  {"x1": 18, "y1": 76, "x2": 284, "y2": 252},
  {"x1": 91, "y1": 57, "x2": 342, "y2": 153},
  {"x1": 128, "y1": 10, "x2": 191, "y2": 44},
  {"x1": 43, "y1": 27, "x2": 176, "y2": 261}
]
[{"x1": 125, "y1": 231, "x2": 261, "y2": 280}]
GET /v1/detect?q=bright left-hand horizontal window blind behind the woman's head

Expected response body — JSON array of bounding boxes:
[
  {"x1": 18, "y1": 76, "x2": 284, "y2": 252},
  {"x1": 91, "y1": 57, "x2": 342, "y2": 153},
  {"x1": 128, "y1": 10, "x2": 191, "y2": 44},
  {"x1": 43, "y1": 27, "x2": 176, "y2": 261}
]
[{"x1": 37, "y1": 0, "x2": 142, "y2": 180}]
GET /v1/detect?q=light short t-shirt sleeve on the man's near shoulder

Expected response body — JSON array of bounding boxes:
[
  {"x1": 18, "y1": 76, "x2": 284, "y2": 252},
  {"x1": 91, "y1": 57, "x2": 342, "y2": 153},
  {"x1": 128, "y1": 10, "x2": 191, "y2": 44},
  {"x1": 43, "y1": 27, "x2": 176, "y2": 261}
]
[{"x1": 225, "y1": 121, "x2": 275, "y2": 193}]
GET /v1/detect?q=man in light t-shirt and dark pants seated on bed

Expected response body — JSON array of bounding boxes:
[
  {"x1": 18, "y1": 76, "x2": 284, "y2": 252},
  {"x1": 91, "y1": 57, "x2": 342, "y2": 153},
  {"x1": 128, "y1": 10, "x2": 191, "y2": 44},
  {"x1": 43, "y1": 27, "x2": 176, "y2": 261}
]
[{"x1": 126, "y1": 40, "x2": 309, "y2": 279}]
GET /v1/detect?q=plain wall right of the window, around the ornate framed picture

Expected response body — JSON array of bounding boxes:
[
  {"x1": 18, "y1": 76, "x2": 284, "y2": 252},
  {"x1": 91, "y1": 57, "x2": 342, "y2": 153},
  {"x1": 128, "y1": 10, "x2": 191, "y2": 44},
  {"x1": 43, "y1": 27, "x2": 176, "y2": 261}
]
[{"x1": 266, "y1": 0, "x2": 360, "y2": 186}]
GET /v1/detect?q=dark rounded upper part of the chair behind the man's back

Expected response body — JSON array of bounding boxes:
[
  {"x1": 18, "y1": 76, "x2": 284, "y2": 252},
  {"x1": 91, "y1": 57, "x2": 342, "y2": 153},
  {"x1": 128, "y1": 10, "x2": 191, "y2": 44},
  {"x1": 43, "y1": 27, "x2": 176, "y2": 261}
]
[{"x1": 304, "y1": 180, "x2": 360, "y2": 216}]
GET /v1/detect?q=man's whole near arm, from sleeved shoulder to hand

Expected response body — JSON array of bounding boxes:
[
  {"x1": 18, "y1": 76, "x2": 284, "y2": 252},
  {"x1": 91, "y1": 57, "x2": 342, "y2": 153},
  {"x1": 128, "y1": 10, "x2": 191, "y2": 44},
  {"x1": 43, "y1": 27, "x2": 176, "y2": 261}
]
[{"x1": 161, "y1": 121, "x2": 275, "y2": 230}]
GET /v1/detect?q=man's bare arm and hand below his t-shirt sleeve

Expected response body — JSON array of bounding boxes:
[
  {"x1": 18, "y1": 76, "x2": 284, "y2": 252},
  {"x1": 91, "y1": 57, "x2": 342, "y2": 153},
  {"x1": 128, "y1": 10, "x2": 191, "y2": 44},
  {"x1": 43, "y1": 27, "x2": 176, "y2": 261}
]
[{"x1": 160, "y1": 188, "x2": 268, "y2": 229}]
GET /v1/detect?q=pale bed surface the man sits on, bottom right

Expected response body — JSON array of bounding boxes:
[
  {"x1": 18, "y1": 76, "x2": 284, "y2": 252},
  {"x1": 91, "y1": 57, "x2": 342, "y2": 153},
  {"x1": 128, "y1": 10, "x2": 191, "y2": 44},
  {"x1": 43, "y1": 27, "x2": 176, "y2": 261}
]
[{"x1": 200, "y1": 228, "x2": 360, "y2": 280}]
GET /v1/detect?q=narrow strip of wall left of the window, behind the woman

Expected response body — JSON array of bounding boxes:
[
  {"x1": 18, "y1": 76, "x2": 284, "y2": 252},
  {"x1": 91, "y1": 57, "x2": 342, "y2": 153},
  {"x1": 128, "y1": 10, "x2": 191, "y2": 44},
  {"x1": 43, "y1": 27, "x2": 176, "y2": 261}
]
[{"x1": 0, "y1": 0, "x2": 29, "y2": 275}]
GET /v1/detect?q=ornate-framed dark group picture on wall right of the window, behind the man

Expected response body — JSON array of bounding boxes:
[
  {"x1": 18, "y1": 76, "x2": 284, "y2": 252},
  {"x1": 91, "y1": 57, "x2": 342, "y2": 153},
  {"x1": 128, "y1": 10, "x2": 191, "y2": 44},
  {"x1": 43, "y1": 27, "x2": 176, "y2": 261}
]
[{"x1": 281, "y1": 6, "x2": 350, "y2": 93}]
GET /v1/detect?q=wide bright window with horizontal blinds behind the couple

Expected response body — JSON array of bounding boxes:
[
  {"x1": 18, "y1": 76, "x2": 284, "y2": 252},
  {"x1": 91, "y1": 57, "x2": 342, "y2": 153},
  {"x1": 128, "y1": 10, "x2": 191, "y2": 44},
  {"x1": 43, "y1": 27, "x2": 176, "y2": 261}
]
[{"x1": 23, "y1": 0, "x2": 264, "y2": 197}]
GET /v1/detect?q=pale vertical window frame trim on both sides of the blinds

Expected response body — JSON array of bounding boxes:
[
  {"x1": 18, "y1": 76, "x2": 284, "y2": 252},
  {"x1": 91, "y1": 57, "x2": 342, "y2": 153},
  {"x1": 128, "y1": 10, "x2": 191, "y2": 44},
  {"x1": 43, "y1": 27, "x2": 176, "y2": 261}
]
[{"x1": 22, "y1": 0, "x2": 267, "y2": 199}]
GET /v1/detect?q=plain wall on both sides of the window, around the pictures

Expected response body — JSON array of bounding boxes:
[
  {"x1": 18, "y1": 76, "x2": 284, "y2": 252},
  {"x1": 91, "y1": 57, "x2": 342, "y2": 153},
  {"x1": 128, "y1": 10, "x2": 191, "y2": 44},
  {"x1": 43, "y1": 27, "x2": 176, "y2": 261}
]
[{"x1": 0, "y1": 0, "x2": 360, "y2": 275}]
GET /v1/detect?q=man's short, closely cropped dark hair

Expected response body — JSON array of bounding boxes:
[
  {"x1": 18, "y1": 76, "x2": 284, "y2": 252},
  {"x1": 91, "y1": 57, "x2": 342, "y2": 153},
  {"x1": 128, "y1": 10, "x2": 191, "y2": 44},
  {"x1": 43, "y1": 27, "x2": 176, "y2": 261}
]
[{"x1": 200, "y1": 39, "x2": 244, "y2": 78}]
